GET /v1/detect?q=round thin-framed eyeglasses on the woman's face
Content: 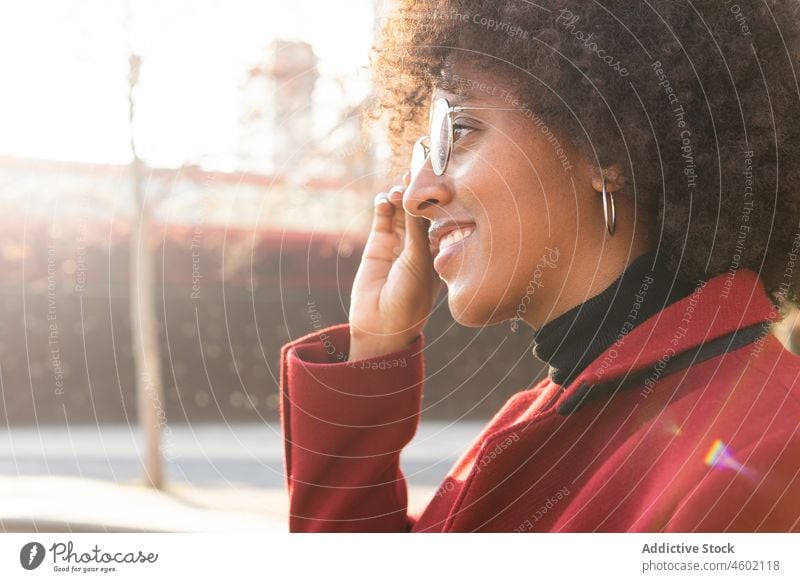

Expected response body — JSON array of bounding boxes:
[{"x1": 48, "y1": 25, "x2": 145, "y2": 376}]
[{"x1": 411, "y1": 97, "x2": 525, "y2": 178}]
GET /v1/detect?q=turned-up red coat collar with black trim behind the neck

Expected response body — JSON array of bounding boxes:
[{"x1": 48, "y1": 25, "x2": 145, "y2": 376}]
[{"x1": 556, "y1": 269, "x2": 778, "y2": 414}]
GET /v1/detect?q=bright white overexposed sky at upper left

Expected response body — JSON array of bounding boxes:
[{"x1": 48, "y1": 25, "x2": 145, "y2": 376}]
[{"x1": 0, "y1": 0, "x2": 374, "y2": 170}]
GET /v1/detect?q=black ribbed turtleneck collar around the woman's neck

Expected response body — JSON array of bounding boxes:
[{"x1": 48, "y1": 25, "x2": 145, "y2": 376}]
[{"x1": 533, "y1": 251, "x2": 694, "y2": 386}]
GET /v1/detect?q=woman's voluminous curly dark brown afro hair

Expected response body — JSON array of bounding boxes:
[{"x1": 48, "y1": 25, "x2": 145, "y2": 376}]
[{"x1": 371, "y1": 0, "x2": 800, "y2": 314}]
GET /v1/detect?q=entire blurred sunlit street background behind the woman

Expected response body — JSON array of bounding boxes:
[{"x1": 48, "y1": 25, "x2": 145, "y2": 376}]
[{"x1": 0, "y1": 0, "x2": 542, "y2": 531}]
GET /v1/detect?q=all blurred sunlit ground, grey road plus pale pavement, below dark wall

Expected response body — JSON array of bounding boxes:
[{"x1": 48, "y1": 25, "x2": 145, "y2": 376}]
[{"x1": 0, "y1": 423, "x2": 483, "y2": 532}]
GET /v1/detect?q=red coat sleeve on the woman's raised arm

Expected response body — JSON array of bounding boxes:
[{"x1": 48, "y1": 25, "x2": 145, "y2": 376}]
[{"x1": 280, "y1": 324, "x2": 424, "y2": 532}]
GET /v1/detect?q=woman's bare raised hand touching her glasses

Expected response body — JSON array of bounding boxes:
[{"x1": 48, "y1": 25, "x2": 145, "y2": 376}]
[{"x1": 348, "y1": 172, "x2": 443, "y2": 361}]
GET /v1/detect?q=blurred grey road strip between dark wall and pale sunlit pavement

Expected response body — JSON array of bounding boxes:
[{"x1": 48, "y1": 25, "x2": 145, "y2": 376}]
[{"x1": 0, "y1": 422, "x2": 482, "y2": 488}]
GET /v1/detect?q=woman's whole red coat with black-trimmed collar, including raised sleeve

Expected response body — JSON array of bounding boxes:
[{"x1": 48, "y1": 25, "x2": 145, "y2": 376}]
[{"x1": 281, "y1": 270, "x2": 800, "y2": 532}]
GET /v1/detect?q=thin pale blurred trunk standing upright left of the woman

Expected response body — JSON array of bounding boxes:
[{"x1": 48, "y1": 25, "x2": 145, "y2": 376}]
[{"x1": 128, "y1": 53, "x2": 166, "y2": 489}]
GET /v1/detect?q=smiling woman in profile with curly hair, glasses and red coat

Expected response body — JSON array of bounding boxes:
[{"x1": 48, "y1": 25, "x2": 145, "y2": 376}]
[{"x1": 281, "y1": 0, "x2": 800, "y2": 532}]
